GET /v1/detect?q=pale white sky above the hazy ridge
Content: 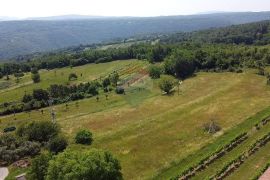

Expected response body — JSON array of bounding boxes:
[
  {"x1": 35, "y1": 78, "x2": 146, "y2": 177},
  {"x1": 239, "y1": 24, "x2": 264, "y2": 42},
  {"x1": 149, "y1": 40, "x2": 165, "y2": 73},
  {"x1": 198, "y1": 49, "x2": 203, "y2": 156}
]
[{"x1": 0, "y1": 0, "x2": 270, "y2": 18}]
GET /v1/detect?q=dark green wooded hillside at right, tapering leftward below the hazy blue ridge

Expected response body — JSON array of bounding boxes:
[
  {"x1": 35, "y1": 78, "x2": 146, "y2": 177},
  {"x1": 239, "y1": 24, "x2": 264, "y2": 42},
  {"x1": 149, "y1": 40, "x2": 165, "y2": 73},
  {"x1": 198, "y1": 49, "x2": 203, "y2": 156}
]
[{"x1": 159, "y1": 20, "x2": 270, "y2": 45}]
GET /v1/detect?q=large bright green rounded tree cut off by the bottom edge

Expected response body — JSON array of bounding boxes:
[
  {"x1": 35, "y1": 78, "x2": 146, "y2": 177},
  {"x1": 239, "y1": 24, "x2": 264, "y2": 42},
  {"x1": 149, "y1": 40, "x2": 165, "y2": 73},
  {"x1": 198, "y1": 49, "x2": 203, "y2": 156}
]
[{"x1": 46, "y1": 149, "x2": 123, "y2": 180}]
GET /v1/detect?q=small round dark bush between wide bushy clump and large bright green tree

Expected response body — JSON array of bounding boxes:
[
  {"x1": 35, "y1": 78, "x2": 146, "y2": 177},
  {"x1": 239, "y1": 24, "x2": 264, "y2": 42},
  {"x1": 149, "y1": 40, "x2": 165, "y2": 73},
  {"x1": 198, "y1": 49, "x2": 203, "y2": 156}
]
[{"x1": 48, "y1": 136, "x2": 68, "y2": 154}]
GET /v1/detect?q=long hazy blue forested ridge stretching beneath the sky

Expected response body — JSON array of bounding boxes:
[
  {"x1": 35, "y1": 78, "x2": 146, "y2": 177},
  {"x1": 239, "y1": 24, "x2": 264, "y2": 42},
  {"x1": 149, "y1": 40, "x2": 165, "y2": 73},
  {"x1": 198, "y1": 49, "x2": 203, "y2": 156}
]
[{"x1": 0, "y1": 12, "x2": 270, "y2": 59}]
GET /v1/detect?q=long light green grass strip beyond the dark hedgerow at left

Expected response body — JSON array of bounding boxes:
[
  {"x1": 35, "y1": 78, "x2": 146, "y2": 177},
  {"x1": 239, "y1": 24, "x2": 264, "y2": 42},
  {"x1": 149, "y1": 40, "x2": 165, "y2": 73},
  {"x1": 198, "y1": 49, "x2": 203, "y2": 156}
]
[{"x1": 0, "y1": 60, "x2": 139, "y2": 102}]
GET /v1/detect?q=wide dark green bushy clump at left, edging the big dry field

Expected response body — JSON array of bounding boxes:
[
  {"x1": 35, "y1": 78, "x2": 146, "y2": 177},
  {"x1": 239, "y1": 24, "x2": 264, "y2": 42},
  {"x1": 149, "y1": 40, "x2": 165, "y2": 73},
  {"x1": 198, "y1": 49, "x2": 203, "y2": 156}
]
[{"x1": 17, "y1": 121, "x2": 59, "y2": 143}]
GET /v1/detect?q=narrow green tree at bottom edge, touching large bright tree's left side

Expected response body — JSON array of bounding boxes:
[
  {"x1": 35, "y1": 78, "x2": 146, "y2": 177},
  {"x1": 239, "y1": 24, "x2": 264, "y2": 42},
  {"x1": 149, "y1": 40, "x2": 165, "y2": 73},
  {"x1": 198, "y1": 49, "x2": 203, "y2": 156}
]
[{"x1": 29, "y1": 153, "x2": 52, "y2": 180}]
